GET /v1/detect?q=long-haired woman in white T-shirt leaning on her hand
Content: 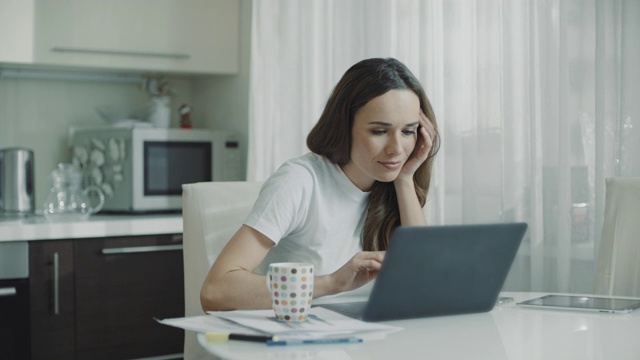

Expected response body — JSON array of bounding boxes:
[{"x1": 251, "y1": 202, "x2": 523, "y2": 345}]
[{"x1": 200, "y1": 59, "x2": 439, "y2": 311}]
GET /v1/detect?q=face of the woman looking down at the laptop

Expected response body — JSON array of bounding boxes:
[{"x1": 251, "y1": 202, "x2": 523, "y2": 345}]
[{"x1": 342, "y1": 90, "x2": 420, "y2": 191}]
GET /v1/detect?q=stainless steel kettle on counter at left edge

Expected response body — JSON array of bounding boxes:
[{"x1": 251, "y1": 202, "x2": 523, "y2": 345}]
[{"x1": 0, "y1": 148, "x2": 35, "y2": 216}]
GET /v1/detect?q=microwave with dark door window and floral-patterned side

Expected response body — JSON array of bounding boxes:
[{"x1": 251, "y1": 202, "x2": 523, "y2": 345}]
[{"x1": 69, "y1": 127, "x2": 244, "y2": 213}]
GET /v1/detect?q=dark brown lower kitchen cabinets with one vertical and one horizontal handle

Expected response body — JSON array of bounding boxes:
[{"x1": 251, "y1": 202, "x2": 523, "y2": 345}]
[{"x1": 30, "y1": 235, "x2": 184, "y2": 359}]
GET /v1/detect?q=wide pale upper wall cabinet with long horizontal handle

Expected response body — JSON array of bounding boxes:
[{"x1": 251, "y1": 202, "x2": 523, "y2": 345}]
[{"x1": 13, "y1": 0, "x2": 240, "y2": 74}]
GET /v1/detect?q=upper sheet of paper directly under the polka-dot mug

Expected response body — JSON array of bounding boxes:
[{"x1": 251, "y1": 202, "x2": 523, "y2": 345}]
[{"x1": 209, "y1": 307, "x2": 402, "y2": 336}]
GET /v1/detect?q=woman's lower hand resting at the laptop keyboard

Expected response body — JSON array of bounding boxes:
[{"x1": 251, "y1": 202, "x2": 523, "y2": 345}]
[{"x1": 328, "y1": 251, "x2": 386, "y2": 293}]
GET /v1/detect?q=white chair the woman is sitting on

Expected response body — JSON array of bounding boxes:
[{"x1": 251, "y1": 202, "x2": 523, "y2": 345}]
[{"x1": 182, "y1": 182, "x2": 262, "y2": 360}]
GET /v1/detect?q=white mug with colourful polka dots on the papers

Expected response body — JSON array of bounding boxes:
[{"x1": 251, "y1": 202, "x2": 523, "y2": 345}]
[{"x1": 267, "y1": 262, "x2": 314, "y2": 322}]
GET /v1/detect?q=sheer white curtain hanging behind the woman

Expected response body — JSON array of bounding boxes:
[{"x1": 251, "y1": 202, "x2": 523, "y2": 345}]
[{"x1": 248, "y1": 0, "x2": 640, "y2": 292}]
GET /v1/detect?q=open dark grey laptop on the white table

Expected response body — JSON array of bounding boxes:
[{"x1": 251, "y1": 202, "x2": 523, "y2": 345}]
[{"x1": 318, "y1": 223, "x2": 527, "y2": 321}]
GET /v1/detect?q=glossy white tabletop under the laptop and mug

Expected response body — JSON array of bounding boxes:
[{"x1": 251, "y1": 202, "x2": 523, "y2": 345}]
[{"x1": 197, "y1": 293, "x2": 640, "y2": 360}]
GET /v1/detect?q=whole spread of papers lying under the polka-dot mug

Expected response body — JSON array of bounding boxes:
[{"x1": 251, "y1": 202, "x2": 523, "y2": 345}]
[{"x1": 158, "y1": 307, "x2": 402, "y2": 338}]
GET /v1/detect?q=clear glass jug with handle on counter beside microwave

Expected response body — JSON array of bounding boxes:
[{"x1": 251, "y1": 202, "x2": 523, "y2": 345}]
[{"x1": 44, "y1": 164, "x2": 104, "y2": 221}]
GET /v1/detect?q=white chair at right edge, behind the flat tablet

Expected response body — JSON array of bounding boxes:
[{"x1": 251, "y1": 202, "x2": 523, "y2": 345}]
[{"x1": 595, "y1": 178, "x2": 640, "y2": 297}]
